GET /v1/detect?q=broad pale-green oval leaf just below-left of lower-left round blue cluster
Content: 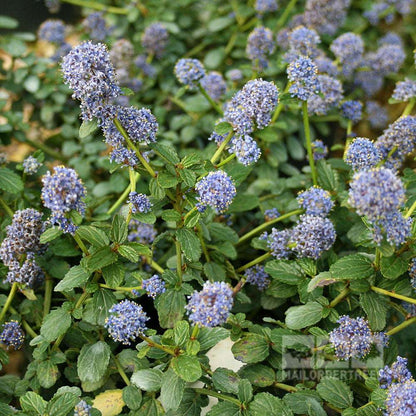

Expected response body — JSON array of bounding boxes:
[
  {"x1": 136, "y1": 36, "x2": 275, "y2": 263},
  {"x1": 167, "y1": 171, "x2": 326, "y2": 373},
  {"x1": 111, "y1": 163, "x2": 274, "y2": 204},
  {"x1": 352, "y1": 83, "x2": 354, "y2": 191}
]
[{"x1": 77, "y1": 341, "x2": 111, "y2": 383}]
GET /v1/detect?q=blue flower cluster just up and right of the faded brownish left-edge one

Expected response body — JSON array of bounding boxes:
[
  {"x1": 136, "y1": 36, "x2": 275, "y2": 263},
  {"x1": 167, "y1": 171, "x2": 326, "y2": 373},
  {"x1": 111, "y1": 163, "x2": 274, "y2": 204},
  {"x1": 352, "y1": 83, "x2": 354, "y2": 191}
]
[{"x1": 41, "y1": 166, "x2": 86, "y2": 234}]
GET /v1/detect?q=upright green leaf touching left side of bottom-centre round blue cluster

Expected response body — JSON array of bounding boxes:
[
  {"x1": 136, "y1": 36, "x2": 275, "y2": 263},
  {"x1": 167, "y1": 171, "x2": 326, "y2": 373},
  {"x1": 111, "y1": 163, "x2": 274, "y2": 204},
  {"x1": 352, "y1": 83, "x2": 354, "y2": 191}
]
[{"x1": 155, "y1": 289, "x2": 186, "y2": 328}]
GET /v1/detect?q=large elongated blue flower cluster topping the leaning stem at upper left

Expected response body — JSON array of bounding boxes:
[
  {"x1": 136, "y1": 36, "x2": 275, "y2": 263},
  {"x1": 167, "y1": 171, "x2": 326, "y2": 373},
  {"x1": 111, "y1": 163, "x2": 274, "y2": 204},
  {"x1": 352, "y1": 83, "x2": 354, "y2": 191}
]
[{"x1": 62, "y1": 41, "x2": 121, "y2": 120}]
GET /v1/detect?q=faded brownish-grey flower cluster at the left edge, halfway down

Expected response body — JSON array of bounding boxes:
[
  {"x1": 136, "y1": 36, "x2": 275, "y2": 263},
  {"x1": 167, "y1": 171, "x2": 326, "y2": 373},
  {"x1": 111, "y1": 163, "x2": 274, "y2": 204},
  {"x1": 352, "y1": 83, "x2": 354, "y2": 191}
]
[{"x1": 0, "y1": 208, "x2": 45, "y2": 287}]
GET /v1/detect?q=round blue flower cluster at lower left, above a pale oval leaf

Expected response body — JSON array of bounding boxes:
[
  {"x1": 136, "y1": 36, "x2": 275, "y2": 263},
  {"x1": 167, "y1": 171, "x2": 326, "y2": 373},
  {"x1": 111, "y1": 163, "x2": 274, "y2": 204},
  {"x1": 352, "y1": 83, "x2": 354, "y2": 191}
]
[{"x1": 104, "y1": 300, "x2": 149, "y2": 345}]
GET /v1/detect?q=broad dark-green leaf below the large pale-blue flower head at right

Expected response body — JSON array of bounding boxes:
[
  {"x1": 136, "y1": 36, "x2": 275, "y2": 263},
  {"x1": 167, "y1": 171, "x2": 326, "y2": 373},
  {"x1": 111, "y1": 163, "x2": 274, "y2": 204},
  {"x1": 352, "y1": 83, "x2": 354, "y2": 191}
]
[{"x1": 329, "y1": 253, "x2": 375, "y2": 280}]
